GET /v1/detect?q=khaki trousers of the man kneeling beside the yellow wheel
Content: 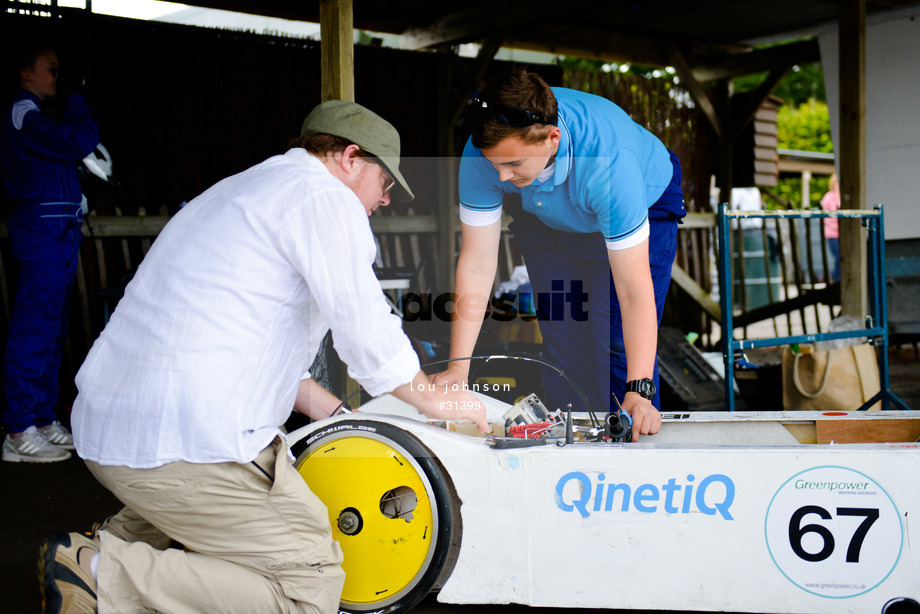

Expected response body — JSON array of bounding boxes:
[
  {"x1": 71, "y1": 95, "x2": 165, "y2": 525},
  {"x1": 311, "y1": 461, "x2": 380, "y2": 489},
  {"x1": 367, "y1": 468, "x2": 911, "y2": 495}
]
[{"x1": 86, "y1": 437, "x2": 345, "y2": 614}]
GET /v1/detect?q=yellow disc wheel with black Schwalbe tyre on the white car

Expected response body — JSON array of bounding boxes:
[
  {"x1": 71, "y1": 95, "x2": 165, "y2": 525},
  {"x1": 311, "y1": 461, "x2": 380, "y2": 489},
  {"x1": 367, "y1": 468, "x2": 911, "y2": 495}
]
[{"x1": 295, "y1": 420, "x2": 460, "y2": 613}]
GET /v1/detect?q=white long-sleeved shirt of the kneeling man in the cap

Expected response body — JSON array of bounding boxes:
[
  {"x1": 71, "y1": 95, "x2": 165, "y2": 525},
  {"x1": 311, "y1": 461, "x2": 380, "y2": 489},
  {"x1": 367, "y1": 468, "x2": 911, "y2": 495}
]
[{"x1": 72, "y1": 148, "x2": 419, "y2": 468}]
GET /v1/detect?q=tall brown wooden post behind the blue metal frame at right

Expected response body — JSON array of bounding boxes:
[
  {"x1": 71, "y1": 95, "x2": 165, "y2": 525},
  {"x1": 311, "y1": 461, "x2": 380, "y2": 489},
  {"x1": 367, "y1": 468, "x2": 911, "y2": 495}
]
[{"x1": 839, "y1": 0, "x2": 868, "y2": 320}]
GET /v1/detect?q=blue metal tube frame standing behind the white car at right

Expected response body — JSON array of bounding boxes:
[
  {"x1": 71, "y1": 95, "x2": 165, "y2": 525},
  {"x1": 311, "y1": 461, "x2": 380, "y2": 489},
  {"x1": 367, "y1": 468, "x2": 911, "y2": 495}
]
[{"x1": 718, "y1": 203, "x2": 910, "y2": 411}]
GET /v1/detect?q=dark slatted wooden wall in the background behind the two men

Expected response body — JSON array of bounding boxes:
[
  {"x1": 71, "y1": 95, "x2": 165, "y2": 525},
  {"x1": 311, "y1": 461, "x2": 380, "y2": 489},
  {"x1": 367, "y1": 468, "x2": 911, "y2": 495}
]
[{"x1": 0, "y1": 11, "x2": 736, "y2": 394}]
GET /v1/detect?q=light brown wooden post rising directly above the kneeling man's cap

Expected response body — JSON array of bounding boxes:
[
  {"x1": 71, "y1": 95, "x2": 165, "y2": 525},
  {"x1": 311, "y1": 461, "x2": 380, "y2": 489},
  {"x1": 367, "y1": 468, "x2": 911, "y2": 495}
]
[{"x1": 319, "y1": 0, "x2": 355, "y2": 102}]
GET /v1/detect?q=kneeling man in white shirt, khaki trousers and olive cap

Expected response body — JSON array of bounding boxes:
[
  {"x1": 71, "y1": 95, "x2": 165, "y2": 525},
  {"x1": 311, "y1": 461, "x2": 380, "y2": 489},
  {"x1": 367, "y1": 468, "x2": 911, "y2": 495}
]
[{"x1": 41, "y1": 101, "x2": 486, "y2": 614}]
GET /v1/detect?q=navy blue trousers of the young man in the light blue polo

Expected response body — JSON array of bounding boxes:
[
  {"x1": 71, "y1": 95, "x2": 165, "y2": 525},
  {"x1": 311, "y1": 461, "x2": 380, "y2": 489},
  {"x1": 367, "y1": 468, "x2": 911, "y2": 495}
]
[{"x1": 507, "y1": 153, "x2": 683, "y2": 411}]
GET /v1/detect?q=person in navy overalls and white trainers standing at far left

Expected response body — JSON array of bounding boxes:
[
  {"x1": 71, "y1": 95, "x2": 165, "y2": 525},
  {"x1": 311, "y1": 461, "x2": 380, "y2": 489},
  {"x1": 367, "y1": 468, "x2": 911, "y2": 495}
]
[{"x1": 0, "y1": 46, "x2": 99, "y2": 462}]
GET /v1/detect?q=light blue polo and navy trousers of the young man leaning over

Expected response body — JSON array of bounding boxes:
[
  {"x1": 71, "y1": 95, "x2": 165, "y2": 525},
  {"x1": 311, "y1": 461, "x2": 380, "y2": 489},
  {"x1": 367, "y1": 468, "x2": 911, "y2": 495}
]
[{"x1": 460, "y1": 88, "x2": 686, "y2": 411}]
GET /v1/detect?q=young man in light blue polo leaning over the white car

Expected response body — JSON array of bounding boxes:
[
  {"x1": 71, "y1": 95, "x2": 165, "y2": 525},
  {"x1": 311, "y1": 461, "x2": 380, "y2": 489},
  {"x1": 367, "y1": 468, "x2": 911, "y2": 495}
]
[{"x1": 432, "y1": 69, "x2": 686, "y2": 440}]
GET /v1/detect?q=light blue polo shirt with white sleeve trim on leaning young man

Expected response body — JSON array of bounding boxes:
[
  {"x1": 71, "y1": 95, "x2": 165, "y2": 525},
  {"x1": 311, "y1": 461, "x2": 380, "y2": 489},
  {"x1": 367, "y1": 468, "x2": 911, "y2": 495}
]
[{"x1": 459, "y1": 87, "x2": 674, "y2": 248}]
